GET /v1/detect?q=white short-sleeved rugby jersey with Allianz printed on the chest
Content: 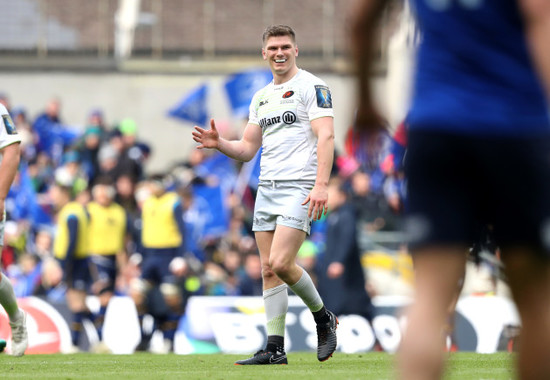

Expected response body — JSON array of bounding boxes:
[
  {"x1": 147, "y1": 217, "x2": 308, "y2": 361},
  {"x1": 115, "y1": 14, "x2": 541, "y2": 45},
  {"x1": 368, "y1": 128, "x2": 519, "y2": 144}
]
[{"x1": 248, "y1": 69, "x2": 334, "y2": 181}]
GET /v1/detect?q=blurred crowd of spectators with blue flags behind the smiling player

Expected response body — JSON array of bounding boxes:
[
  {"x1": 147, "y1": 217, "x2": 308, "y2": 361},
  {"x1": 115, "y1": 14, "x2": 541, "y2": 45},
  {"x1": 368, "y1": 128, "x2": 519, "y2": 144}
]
[{"x1": 0, "y1": 95, "x2": 404, "y2": 314}]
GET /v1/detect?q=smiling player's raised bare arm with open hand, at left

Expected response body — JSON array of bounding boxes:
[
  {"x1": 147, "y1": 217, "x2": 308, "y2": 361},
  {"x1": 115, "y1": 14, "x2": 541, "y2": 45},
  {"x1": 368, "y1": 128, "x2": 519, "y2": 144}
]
[{"x1": 193, "y1": 119, "x2": 262, "y2": 161}]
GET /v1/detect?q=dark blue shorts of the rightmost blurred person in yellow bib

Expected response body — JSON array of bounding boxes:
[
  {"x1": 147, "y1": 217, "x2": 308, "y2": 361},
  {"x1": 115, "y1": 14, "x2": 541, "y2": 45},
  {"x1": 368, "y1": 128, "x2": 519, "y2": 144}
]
[{"x1": 141, "y1": 248, "x2": 181, "y2": 285}]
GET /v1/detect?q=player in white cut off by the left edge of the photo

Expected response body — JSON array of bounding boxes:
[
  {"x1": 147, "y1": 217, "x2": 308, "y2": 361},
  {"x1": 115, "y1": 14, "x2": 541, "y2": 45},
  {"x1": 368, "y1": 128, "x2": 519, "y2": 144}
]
[{"x1": 0, "y1": 104, "x2": 28, "y2": 356}]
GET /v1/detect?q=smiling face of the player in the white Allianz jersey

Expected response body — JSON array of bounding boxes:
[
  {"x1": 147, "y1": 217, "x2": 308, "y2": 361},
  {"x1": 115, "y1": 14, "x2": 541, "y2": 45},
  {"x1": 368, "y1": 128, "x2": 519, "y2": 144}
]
[{"x1": 262, "y1": 36, "x2": 298, "y2": 84}]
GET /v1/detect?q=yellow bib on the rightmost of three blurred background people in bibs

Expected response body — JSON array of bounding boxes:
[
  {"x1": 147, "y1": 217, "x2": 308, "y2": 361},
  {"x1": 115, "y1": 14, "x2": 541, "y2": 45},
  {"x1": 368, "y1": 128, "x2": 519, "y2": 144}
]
[{"x1": 141, "y1": 192, "x2": 182, "y2": 248}]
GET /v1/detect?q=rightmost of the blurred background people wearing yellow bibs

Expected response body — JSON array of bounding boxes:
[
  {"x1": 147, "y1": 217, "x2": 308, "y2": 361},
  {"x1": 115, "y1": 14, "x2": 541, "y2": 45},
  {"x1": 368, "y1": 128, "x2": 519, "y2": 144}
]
[{"x1": 132, "y1": 175, "x2": 187, "y2": 352}]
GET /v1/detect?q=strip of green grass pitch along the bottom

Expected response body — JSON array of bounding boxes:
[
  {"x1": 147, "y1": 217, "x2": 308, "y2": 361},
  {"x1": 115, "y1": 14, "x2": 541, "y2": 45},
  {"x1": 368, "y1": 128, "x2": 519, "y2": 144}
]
[{"x1": 0, "y1": 352, "x2": 514, "y2": 380}]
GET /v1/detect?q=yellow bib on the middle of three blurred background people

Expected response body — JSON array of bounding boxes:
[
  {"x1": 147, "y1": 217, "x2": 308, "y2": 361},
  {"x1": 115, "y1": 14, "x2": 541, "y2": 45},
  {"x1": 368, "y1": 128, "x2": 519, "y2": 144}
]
[{"x1": 87, "y1": 202, "x2": 126, "y2": 255}]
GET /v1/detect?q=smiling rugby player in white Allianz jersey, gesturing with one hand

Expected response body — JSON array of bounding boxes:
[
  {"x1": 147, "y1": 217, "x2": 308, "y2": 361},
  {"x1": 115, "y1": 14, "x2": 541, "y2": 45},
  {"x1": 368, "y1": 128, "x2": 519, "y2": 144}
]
[{"x1": 193, "y1": 25, "x2": 338, "y2": 365}]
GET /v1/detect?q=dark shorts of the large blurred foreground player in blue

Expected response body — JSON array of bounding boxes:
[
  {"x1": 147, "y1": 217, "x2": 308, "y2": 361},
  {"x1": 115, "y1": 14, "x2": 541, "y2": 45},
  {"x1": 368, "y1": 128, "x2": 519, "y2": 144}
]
[{"x1": 405, "y1": 131, "x2": 550, "y2": 252}]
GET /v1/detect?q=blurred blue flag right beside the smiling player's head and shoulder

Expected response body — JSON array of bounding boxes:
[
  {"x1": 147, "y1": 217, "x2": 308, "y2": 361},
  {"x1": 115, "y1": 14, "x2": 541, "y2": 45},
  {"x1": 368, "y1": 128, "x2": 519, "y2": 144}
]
[{"x1": 225, "y1": 69, "x2": 273, "y2": 118}]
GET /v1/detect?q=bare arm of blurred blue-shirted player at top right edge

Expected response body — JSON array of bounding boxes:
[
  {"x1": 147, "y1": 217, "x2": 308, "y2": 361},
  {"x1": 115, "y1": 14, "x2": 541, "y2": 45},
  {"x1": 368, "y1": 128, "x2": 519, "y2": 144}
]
[{"x1": 519, "y1": 0, "x2": 550, "y2": 96}]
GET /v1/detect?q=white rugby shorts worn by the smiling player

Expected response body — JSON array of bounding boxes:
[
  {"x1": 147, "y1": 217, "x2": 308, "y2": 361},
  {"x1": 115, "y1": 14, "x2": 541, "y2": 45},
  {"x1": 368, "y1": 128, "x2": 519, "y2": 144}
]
[{"x1": 252, "y1": 181, "x2": 315, "y2": 235}]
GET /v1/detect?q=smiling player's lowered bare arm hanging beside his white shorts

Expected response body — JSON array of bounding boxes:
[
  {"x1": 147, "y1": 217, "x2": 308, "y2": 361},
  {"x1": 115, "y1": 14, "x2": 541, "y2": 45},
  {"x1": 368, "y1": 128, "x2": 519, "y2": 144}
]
[{"x1": 302, "y1": 117, "x2": 334, "y2": 220}]
